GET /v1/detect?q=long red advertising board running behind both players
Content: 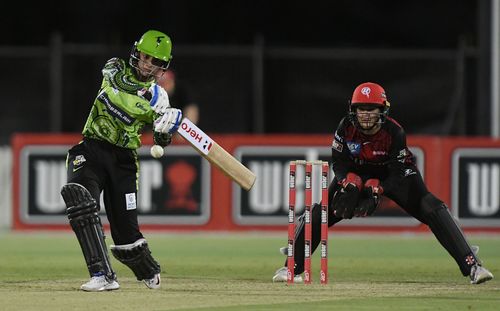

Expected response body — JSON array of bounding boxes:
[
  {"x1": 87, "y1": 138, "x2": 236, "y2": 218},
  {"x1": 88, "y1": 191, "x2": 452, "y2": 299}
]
[{"x1": 12, "y1": 134, "x2": 500, "y2": 232}]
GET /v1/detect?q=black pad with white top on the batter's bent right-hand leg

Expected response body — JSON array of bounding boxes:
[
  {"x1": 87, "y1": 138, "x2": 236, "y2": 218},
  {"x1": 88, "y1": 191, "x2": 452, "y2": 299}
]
[{"x1": 111, "y1": 239, "x2": 161, "y2": 281}]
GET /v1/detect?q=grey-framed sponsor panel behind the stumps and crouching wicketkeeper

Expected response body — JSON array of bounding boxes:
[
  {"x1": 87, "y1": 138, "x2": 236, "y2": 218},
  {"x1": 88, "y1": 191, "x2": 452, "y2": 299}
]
[{"x1": 233, "y1": 146, "x2": 424, "y2": 226}]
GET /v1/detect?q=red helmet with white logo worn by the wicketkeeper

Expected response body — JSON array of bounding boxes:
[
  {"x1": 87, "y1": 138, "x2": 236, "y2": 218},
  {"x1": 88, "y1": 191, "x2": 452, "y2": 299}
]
[{"x1": 349, "y1": 82, "x2": 391, "y2": 125}]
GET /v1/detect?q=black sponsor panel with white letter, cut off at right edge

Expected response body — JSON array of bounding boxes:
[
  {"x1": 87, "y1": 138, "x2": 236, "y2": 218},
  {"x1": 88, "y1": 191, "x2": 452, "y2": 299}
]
[{"x1": 452, "y1": 148, "x2": 500, "y2": 227}]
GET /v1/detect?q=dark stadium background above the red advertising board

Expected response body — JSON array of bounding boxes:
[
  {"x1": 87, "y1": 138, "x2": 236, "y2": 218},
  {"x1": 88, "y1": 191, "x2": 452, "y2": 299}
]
[{"x1": 0, "y1": 0, "x2": 490, "y2": 143}]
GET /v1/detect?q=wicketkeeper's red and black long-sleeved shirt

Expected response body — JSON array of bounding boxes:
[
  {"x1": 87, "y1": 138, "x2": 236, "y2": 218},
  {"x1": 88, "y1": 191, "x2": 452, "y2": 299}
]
[{"x1": 332, "y1": 117, "x2": 417, "y2": 192}]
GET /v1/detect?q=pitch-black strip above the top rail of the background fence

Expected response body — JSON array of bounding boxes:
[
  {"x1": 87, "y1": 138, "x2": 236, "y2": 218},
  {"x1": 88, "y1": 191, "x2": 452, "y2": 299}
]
[{"x1": 2, "y1": 0, "x2": 478, "y2": 48}]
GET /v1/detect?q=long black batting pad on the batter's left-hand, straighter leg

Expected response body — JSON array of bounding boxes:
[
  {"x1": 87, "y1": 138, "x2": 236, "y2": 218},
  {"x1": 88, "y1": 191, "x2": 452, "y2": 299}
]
[{"x1": 61, "y1": 183, "x2": 115, "y2": 279}]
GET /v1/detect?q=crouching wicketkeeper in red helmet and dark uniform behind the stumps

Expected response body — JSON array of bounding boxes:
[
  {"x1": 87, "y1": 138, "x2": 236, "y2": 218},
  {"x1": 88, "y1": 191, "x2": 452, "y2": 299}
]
[{"x1": 273, "y1": 82, "x2": 493, "y2": 284}]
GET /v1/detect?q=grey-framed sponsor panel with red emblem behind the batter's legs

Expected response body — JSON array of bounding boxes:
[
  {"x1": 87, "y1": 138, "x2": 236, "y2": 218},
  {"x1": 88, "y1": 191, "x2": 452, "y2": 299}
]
[{"x1": 17, "y1": 145, "x2": 211, "y2": 225}]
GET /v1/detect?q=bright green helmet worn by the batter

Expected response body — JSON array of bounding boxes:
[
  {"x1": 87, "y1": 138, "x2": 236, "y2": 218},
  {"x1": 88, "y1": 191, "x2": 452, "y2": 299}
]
[{"x1": 129, "y1": 30, "x2": 172, "y2": 78}]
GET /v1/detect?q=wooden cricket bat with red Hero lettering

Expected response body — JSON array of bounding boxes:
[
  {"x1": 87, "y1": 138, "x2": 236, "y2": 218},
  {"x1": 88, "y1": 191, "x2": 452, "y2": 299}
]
[{"x1": 173, "y1": 118, "x2": 256, "y2": 191}]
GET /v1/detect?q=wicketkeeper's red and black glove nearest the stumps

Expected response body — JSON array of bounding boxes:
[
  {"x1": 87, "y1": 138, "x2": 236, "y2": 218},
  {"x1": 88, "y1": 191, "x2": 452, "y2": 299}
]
[{"x1": 332, "y1": 173, "x2": 362, "y2": 219}]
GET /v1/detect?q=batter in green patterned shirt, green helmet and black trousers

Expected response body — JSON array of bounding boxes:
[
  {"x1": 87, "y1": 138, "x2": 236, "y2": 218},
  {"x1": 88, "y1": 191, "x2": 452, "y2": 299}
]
[{"x1": 61, "y1": 30, "x2": 182, "y2": 292}]
